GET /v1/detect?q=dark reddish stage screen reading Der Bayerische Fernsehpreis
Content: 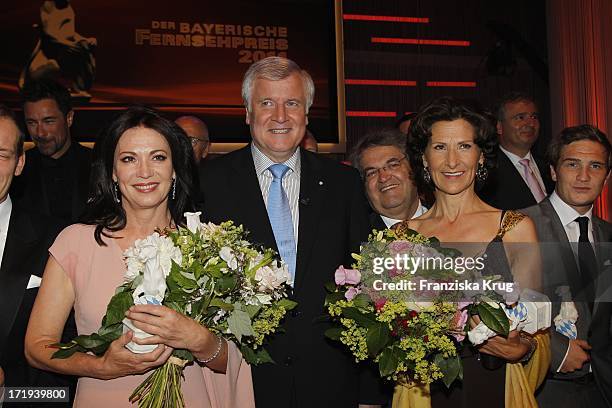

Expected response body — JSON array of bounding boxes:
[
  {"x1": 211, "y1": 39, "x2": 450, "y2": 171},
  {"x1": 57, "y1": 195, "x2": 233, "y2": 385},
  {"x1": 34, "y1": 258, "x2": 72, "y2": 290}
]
[{"x1": 0, "y1": 0, "x2": 344, "y2": 151}]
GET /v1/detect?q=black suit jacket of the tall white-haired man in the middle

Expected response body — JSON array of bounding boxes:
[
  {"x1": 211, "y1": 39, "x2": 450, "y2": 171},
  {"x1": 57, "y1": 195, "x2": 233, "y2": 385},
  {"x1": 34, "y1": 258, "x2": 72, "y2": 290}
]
[{"x1": 201, "y1": 146, "x2": 383, "y2": 408}]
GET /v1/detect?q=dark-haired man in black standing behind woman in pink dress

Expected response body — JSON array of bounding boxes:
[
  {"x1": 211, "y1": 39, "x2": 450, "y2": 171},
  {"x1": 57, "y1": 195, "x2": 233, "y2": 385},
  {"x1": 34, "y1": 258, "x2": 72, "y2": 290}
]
[{"x1": 11, "y1": 79, "x2": 91, "y2": 225}]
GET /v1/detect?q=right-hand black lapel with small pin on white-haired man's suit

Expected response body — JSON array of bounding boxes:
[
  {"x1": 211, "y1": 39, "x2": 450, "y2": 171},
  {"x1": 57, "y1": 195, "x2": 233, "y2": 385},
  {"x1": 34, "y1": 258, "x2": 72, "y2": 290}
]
[{"x1": 294, "y1": 152, "x2": 327, "y2": 291}]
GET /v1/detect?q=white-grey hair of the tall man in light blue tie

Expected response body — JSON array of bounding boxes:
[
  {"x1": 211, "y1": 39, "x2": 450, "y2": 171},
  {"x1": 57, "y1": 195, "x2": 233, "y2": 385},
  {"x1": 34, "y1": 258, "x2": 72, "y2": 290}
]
[{"x1": 242, "y1": 57, "x2": 314, "y2": 113}]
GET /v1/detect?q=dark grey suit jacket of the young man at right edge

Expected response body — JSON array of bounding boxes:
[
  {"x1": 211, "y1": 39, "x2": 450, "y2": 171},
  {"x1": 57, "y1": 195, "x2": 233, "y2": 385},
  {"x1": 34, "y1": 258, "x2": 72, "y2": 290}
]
[{"x1": 521, "y1": 198, "x2": 612, "y2": 402}]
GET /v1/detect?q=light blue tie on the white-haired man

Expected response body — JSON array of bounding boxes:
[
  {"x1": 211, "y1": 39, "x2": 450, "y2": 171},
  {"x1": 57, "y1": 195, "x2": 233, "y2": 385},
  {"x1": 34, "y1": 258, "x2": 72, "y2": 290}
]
[{"x1": 268, "y1": 164, "x2": 296, "y2": 278}]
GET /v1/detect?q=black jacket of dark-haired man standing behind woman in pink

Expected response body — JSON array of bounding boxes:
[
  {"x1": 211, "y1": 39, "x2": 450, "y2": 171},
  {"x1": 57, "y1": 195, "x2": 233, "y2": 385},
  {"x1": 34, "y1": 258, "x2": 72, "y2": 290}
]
[{"x1": 11, "y1": 141, "x2": 92, "y2": 225}]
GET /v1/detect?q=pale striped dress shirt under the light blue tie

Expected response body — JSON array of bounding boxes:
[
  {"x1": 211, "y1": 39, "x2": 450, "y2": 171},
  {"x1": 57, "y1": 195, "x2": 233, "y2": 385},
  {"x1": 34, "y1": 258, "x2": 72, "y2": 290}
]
[{"x1": 251, "y1": 143, "x2": 301, "y2": 246}]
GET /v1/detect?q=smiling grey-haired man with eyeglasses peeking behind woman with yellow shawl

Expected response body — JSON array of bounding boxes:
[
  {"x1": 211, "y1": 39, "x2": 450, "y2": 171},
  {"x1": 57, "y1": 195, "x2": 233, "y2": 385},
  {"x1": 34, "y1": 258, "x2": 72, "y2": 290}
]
[{"x1": 352, "y1": 129, "x2": 427, "y2": 230}]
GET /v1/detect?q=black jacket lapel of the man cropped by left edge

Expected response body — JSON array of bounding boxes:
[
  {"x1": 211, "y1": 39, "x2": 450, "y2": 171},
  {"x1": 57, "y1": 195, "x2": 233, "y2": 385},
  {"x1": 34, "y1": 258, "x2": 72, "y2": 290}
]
[{"x1": 0, "y1": 207, "x2": 37, "y2": 352}]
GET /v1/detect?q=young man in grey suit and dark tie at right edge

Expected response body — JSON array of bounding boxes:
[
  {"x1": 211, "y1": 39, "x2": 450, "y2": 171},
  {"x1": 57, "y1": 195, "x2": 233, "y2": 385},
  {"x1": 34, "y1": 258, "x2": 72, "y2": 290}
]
[{"x1": 521, "y1": 125, "x2": 612, "y2": 408}]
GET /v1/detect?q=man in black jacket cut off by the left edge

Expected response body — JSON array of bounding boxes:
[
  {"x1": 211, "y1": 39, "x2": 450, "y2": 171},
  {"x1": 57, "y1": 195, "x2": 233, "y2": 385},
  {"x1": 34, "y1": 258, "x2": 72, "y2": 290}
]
[{"x1": 0, "y1": 106, "x2": 76, "y2": 407}]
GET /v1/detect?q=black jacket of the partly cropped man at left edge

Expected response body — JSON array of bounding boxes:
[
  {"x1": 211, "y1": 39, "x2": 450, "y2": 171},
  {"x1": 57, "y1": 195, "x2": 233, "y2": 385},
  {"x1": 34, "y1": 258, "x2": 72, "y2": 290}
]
[{"x1": 0, "y1": 204, "x2": 76, "y2": 407}]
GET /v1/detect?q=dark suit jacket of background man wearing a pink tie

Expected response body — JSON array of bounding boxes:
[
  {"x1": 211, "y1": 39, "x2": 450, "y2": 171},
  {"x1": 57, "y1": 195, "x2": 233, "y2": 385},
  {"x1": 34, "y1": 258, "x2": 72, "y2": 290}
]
[{"x1": 478, "y1": 147, "x2": 555, "y2": 210}]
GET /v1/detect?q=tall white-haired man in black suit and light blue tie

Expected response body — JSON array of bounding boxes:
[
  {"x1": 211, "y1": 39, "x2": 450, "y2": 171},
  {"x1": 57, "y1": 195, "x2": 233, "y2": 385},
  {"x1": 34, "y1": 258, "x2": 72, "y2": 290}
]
[{"x1": 201, "y1": 57, "x2": 382, "y2": 408}]
